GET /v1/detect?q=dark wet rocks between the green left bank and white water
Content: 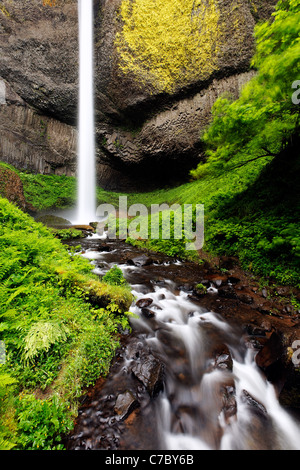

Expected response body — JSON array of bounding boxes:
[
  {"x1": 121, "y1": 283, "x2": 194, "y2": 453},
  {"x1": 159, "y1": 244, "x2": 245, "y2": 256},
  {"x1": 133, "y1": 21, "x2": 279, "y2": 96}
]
[{"x1": 67, "y1": 336, "x2": 164, "y2": 450}]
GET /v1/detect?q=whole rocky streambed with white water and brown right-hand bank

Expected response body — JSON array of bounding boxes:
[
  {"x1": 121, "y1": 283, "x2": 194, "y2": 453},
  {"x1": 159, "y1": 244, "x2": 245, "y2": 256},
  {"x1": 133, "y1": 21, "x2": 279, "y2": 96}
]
[{"x1": 66, "y1": 236, "x2": 300, "y2": 450}]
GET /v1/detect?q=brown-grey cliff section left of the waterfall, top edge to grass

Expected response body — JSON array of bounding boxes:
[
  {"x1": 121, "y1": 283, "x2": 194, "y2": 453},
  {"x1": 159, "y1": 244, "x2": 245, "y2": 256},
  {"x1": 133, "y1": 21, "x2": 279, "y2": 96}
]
[{"x1": 0, "y1": 0, "x2": 78, "y2": 175}]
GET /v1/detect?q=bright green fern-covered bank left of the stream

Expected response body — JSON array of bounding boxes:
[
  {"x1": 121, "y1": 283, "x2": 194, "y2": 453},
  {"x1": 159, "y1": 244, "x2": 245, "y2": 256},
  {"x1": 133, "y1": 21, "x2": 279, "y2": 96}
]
[{"x1": 0, "y1": 199, "x2": 131, "y2": 449}]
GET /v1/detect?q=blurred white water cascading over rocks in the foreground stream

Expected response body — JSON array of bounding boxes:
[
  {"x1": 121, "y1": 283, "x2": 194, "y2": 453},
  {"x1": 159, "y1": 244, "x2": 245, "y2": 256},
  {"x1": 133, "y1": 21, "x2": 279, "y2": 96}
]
[{"x1": 131, "y1": 280, "x2": 300, "y2": 450}]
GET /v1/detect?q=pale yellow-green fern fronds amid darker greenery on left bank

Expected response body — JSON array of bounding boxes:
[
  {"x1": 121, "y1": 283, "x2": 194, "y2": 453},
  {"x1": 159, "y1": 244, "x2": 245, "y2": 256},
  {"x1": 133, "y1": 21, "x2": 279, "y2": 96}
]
[{"x1": 24, "y1": 321, "x2": 70, "y2": 361}]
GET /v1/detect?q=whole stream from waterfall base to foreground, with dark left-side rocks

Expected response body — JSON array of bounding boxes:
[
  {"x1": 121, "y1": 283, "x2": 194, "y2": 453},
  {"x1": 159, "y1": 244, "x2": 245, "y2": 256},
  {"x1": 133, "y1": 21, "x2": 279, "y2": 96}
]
[{"x1": 66, "y1": 235, "x2": 300, "y2": 451}]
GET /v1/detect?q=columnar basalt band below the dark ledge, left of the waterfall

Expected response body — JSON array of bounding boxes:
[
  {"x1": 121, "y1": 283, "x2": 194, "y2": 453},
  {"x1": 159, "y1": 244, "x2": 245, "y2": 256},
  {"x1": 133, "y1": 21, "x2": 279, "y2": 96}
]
[{"x1": 0, "y1": 80, "x2": 77, "y2": 176}]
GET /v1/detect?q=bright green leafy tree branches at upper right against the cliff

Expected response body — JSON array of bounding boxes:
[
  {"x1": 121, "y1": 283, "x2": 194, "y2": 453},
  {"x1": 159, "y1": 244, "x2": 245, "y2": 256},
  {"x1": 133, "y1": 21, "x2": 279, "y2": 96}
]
[{"x1": 192, "y1": 0, "x2": 300, "y2": 178}]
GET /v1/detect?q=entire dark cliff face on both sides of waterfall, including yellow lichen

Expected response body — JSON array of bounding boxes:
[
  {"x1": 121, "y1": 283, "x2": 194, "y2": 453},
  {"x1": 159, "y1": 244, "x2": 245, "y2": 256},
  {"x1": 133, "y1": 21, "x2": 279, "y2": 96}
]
[{"x1": 0, "y1": 0, "x2": 276, "y2": 190}]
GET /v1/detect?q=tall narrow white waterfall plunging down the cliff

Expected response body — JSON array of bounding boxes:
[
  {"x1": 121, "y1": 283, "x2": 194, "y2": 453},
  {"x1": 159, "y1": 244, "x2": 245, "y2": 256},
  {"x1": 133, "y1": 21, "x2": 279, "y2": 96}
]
[{"x1": 76, "y1": 0, "x2": 96, "y2": 224}]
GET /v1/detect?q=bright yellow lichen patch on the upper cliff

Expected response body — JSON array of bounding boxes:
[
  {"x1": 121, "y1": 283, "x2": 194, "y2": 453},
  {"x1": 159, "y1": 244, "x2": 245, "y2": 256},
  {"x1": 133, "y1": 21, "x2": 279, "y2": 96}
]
[{"x1": 116, "y1": 0, "x2": 220, "y2": 93}]
